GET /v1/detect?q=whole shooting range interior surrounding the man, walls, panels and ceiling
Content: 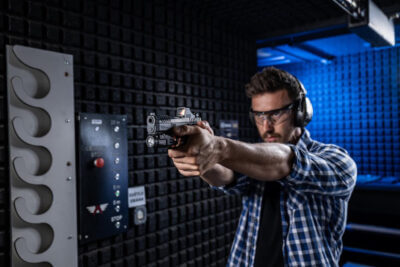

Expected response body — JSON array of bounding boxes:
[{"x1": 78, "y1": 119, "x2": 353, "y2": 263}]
[{"x1": 0, "y1": 0, "x2": 400, "y2": 267}]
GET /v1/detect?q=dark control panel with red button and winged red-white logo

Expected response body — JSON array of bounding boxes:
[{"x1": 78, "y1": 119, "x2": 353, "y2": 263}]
[{"x1": 78, "y1": 113, "x2": 129, "y2": 243}]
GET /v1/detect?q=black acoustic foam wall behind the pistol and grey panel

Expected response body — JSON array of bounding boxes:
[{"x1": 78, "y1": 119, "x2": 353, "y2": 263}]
[{"x1": 0, "y1": 0, "x2": 256, "y2": 266}]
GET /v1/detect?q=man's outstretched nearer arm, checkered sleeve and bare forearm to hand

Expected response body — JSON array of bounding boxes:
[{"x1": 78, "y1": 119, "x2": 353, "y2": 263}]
[{"x1": 170, "y1": 123, "x2": 357, "y2": 196}]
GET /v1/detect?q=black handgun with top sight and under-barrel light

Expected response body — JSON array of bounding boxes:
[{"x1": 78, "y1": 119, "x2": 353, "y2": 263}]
[{"x1": 146, "y1": 107, "x2": 201, "y2": 147}]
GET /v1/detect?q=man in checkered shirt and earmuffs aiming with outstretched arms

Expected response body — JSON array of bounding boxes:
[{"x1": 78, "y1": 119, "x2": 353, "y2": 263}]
[{"x1": 168, "y1": 67, "x2": 357, "y2": 266}]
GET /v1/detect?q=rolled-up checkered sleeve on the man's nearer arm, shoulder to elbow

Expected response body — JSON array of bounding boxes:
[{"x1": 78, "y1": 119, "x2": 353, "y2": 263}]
[{"x1": 280, "y1": 145, "x2": 357, "y2": 196}]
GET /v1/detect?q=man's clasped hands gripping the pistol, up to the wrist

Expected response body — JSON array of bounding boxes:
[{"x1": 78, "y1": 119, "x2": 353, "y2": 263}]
[{"x1": 168, "y1": 121, "x2": 221, "y2": 176}]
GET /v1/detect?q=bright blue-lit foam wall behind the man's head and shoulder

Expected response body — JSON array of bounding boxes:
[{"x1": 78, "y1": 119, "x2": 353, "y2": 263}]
[{"x1": 277, "y1": 47, "x2": 400, "y2": 177}]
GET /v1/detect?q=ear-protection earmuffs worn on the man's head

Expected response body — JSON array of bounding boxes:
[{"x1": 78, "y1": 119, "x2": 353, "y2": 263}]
[{"x1": 249, "y1": 75, "x2": 313, "y2": 128}]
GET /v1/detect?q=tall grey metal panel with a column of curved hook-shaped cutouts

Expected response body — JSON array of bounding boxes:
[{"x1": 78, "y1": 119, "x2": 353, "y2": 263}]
[{"x1": 7, "y1": 45, "x2": 78, "y2": 267}]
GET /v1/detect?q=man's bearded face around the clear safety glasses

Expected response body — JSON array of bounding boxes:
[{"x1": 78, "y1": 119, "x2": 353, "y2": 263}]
[{"x1": 251, "y1": 90, "x2": 300, "y2": 143}]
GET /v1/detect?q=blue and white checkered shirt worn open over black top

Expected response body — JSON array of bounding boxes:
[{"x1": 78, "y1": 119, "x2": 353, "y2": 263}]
[{"x1": 214, "y1": 130, "x2": 357, "y2": 267}]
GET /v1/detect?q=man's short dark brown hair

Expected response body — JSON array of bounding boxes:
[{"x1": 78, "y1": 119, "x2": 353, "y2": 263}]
[{"x1": 246, "y1": 67, "x2": 301, "y2": 101}]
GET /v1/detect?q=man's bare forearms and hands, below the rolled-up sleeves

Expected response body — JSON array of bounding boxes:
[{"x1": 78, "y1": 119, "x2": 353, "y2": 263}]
[{"x1": 168, "y1": 122, "x2": 293, "y2": 186}]
